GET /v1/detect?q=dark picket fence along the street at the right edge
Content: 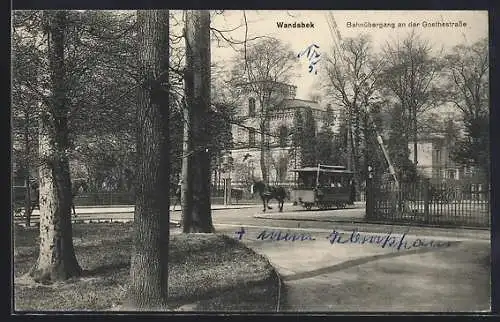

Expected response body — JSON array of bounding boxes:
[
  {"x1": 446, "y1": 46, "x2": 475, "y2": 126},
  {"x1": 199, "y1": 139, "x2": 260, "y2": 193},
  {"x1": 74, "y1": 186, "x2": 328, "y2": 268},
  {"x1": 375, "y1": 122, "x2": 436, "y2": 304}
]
[{"x1": 366, "y1": 180, "x2": 491, "y2": 227}]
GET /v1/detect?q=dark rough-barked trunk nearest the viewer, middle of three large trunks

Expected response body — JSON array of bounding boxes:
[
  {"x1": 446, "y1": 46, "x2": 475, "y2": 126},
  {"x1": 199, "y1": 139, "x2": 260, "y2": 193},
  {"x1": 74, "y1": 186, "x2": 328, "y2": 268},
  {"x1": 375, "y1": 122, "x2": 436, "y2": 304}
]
[{"x1": 126, "y1": 10, "x2": 170, "y2": 310}]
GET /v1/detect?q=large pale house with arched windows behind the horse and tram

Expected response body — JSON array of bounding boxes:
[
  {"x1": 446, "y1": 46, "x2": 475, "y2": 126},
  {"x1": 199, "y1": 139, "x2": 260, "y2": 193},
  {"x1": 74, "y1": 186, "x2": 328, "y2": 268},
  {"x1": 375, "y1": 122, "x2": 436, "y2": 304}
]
[{"x1": 231, "y1": 83, "x2": 338, "y2": 186}]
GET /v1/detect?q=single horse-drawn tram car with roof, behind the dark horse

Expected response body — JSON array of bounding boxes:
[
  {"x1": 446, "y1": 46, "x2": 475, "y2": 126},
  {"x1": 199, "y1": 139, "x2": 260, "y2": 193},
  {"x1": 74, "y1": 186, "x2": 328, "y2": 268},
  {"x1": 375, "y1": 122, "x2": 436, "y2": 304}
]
[{"x1": 291, "y1": 164, "x2": 354, "y2": 210}]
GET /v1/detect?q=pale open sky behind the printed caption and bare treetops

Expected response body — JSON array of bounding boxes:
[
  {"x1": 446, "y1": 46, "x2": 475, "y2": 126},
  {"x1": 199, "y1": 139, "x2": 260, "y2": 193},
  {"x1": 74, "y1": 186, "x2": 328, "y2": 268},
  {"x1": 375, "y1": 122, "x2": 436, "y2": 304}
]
[{"x1": 207, "y1": 10, "x2": 488, "y2": 99}]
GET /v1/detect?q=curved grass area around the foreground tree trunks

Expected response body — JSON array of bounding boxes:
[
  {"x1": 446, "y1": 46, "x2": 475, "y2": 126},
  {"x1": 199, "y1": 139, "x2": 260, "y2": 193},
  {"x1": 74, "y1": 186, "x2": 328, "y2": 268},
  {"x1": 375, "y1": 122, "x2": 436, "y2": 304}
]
[{"x1": 14, "y1": 223, "x2": 278, "y2": 311}]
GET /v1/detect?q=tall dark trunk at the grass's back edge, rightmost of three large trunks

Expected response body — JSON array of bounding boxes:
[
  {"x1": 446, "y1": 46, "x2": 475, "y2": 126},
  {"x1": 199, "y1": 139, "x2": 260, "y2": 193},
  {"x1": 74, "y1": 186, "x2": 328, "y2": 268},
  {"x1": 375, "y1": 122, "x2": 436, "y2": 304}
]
[{"x1": 183, "y1": 10, "x2": 214, "y2": 233}]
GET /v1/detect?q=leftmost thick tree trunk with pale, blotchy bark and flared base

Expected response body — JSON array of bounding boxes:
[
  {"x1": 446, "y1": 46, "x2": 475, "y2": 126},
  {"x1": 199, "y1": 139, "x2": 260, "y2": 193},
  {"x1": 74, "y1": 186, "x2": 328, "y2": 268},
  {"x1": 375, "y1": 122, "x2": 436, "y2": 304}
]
[{"x1": 30, "y1": 11, "x2": 81, "y2": 282}]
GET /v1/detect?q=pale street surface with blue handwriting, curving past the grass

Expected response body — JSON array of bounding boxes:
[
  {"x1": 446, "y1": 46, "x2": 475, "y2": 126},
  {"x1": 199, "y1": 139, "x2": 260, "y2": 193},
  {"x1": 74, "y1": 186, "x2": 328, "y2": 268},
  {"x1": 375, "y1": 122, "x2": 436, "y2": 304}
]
[{"x1": 14, "y1": 203, "x2": 491, "y2": 312}]
